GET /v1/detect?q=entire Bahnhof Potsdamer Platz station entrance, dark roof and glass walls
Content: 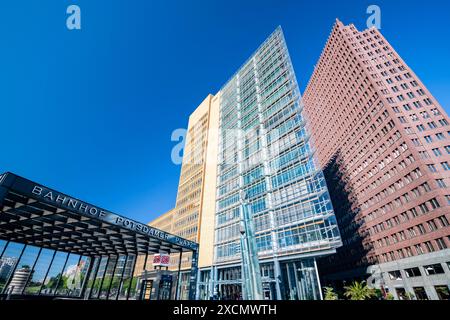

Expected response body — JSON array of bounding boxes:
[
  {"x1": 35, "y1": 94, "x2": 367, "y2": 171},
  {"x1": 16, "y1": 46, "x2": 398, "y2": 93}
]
[{"x1": 0, "y1": 173, "x2": 198, "y2": 300}]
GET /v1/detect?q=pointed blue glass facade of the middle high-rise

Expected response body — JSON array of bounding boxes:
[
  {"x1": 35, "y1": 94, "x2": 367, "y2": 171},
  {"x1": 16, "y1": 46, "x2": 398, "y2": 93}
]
[{"x1": 214, "y1": 28, "x2": 340, "y2": 299}]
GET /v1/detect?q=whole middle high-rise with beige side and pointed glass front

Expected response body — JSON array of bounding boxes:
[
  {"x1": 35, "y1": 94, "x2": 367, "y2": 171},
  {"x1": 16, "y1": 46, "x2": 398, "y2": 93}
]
[{"x1": 150, "y1": 28, "x2": 341, "y2": 299}]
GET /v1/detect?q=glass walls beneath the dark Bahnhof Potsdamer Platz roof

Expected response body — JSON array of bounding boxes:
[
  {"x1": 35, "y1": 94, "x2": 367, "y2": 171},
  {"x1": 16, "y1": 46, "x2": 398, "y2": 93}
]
[{"x1": 0, "y1": 240, "x2": 191, "y2": 300}]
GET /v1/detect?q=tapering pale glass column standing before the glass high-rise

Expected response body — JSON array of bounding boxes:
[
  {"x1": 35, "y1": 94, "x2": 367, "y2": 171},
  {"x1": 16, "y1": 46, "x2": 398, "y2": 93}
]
[{"x1": 240, "y1": 191, "x2": 263, "y2": 300}]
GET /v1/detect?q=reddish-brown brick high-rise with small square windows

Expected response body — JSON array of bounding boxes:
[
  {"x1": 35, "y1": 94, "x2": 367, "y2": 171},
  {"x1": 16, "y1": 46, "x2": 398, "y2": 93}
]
[{"x1": 303, "y1": 21, "x2": 450, "y2": 299}]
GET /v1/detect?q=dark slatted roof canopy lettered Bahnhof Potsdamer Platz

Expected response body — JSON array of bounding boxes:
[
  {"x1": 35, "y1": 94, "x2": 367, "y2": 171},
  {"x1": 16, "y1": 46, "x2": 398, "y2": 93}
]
[{"x1": 0, "y1": 173, "x2": 198, "y2": 298}]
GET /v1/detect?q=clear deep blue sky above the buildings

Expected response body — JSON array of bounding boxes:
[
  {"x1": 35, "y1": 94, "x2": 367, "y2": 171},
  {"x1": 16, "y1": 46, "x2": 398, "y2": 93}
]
[{"x1": 0, "y1": 0, "x2": 450, "y2": 222}]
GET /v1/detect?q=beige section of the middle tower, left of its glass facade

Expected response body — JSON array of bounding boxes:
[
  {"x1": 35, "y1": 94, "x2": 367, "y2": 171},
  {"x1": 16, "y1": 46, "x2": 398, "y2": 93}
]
[{"x1": 136, "y1": 95, "x2": 219, "y2": 299}]
